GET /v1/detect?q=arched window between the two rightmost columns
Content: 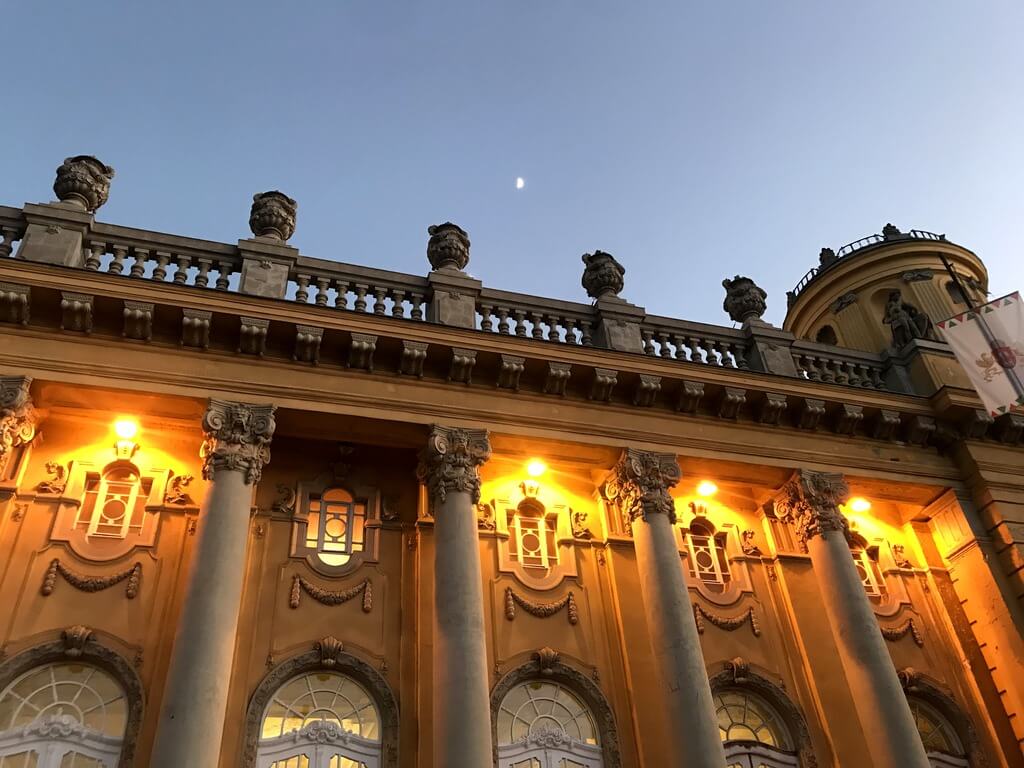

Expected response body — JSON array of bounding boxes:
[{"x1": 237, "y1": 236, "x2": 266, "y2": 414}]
[{"x1": 715, "y1": 688, "x2": 800, "y2": 768}]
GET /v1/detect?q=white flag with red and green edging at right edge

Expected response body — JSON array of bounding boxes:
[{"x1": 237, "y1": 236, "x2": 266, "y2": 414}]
[{"x1": 936, "y1": 293, "x2": 1024, "y2": 416}]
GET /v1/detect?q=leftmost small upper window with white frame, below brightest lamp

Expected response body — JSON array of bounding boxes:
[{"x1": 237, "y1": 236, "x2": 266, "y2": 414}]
[{"x1": 75, "y1": 462, "x2": 153, "y2": 539}]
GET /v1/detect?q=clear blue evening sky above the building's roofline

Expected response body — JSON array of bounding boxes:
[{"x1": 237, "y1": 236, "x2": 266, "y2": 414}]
[{"x1": 0, "y1": 0, "x2": 1024, "y2": 324}]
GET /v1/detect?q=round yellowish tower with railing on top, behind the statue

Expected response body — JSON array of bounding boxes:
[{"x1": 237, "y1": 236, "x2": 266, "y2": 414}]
[{"x1": 782, "y1": 224, "x2": 988, "y2": 352}]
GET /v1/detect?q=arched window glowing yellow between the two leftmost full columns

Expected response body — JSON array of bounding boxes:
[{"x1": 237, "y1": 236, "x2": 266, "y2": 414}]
[{"x1": 256, "y1": 672, "x2": 381, "y2": 768}]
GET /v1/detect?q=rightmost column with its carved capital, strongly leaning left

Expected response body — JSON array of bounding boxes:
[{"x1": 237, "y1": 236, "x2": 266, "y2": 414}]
[{"x1": 775, "y1": 470, "x2": 929, "y2": 768}]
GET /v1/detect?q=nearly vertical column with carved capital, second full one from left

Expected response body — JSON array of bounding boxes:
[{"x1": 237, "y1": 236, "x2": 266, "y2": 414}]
[{"x1": 417, "y1": 426, "x2": 494, "y2": 768}]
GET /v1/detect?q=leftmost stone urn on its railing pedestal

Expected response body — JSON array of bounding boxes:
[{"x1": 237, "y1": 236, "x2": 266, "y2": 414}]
[{"x1": 14, "y1": 155, "x2": 114, "y2": 267}]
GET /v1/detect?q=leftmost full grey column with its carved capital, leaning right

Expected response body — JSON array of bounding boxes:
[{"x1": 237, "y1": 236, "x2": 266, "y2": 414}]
[{"x1": 150, "y1": 399, "x2": 274, "y2": 768}]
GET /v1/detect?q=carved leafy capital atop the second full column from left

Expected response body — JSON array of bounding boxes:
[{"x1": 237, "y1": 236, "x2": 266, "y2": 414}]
[{"x1": 416, "y1": 424, "x2": 490, "y2": 504}]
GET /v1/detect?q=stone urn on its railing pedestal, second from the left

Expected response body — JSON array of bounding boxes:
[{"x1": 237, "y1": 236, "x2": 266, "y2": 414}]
[{"x1": 239, "y1": 189, "x2": 299, "y2": 299}]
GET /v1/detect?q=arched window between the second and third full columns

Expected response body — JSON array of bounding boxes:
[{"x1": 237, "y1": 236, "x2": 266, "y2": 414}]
[{"x1": 497, "y1": 680, "x2": 603, "y2": 768}]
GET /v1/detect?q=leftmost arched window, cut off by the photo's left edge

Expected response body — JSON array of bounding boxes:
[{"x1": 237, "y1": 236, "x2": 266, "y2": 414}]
[{"x1": 0, "y1": 663, "x2": 128, "y2": 768}]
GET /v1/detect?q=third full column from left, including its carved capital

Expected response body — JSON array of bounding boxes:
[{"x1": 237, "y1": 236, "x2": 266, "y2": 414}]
[{"x1": 604, "y1": 449, "x2": 725, "y2": 768}]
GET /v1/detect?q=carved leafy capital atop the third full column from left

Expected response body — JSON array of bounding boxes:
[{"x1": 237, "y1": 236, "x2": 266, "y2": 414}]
[{"x1": 604, "y1": 449, "x2": 682, "y2": 522}]
